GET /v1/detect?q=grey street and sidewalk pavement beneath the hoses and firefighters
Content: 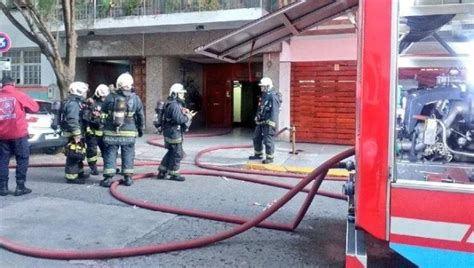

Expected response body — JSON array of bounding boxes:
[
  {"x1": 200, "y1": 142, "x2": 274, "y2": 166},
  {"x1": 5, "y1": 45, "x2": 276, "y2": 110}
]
[{"x1": 0, "y1": 129, "x2": 407, "y2": 267}]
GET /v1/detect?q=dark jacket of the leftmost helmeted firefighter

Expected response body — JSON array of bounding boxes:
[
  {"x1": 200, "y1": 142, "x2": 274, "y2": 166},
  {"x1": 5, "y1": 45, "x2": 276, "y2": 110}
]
[{"x1": 61, "y1": 95, "x2": 84, "y2": 137}]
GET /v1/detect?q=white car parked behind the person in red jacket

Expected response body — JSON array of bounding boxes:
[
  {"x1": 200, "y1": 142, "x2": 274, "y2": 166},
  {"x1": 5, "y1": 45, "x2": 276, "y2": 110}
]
[{"x1": 26, "y1": 100, "x2": 66, "y2": 153}]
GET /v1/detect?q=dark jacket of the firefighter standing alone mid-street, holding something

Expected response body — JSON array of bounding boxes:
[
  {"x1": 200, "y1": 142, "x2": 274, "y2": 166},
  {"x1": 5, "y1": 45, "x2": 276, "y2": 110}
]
[{"x1": 163, "y1": 98, "x2": 192, "y2": 144}]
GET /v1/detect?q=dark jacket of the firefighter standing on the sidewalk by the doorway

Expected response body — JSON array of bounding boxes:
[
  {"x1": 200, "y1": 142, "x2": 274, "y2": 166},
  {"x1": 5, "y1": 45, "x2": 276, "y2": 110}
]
[{"x1": 255, "y1": 88, "x2": 281, "y2": 128}]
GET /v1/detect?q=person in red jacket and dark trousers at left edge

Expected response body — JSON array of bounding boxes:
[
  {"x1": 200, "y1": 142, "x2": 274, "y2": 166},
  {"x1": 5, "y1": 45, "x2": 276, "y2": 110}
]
[{"x1": 0, "y1": 76, "x2": 39, "y2": 196}]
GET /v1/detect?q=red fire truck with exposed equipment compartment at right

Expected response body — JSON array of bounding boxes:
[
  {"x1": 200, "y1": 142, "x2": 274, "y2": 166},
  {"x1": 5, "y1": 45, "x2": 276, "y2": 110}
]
[{"x1": 346, "y1": 0, "x2": 474, "y2": 267}]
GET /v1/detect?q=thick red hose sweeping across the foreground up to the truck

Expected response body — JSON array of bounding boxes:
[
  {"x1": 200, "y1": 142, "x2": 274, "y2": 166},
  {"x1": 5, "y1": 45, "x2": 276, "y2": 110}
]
[{"x1": 0, "y1": 148, "x2": 354, "y2": 260}]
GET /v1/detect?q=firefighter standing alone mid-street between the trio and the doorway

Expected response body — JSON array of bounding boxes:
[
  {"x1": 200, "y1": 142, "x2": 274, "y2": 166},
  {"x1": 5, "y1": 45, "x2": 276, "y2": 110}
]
[{"x1": 157, "y1": 83, "x2": 196, "y2": 181}]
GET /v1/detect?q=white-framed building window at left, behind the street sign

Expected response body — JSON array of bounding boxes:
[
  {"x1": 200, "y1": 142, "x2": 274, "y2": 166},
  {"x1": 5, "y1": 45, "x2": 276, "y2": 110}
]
[{"x1": 2, "y1": 49, "x2": 41, "y2": 85}]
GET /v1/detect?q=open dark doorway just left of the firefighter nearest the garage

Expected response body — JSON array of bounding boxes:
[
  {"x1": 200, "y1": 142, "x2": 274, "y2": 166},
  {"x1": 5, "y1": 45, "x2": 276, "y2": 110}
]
[{"x1": 232, "y1": 80, "x2": 260, "y2": 128}]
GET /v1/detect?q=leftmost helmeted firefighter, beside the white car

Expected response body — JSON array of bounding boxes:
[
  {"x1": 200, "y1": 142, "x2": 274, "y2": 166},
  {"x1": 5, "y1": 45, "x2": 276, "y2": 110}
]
[{"x1": 61, "y1": 82, "x2": 89, "y2": 184}]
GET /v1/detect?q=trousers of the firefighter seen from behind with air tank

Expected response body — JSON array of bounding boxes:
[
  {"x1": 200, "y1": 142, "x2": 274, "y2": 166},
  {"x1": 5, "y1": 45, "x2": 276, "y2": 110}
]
[{"x1": 102, "y1": 143, "x2": 135, "y2": 177}]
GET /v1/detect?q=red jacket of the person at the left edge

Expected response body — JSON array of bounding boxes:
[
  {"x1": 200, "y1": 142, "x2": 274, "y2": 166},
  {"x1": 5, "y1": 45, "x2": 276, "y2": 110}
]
[{"x1": 0, "y1": 85, "x2": 39, "y2": 140}]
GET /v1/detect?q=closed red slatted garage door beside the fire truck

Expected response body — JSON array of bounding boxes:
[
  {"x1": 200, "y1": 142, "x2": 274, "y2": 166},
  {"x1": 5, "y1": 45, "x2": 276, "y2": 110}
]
[{"x1": 291, "y1": 61, "x2": 357, "y2": 145}]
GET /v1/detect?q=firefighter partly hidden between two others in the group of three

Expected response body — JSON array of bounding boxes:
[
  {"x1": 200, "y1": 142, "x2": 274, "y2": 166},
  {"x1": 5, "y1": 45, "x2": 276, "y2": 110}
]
[{"x1": 84, "y1": 84, "x2": 110, "y2": 175}]
